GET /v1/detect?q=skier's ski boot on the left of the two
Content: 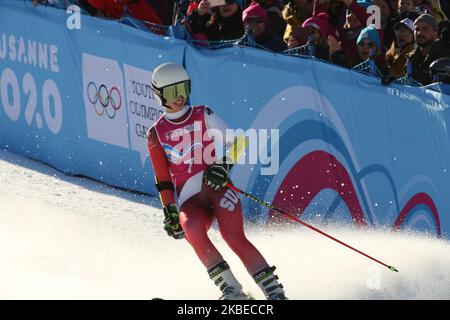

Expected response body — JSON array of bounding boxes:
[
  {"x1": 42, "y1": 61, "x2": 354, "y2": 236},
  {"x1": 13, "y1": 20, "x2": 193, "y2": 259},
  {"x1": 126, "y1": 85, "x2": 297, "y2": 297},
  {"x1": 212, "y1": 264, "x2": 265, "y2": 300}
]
[{"x1": 208, "y1": 261, "x2": 252, "y2": 300}]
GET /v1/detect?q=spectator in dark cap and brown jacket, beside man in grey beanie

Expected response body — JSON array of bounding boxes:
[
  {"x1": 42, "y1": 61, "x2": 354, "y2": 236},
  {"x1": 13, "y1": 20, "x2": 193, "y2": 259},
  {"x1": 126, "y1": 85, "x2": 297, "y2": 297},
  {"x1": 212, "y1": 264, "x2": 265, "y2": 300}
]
[{"x1": 386, "y1": 18, "x2": 415, "y2": 79}]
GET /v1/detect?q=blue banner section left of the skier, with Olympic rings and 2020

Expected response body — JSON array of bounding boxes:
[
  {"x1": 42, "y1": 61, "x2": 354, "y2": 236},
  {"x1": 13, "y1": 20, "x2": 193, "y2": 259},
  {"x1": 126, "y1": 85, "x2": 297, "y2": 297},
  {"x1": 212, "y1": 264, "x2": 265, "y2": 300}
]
[{"x1": 0, "y1": 0, "x2": 185, "y2": 193}]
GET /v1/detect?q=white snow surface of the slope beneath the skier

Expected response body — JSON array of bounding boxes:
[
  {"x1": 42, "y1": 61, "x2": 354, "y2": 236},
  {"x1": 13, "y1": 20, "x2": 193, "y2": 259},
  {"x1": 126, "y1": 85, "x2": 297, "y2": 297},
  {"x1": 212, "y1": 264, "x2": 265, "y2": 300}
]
[{"x1": 0, "y1": 150, "x2": 450, "y2": 299}]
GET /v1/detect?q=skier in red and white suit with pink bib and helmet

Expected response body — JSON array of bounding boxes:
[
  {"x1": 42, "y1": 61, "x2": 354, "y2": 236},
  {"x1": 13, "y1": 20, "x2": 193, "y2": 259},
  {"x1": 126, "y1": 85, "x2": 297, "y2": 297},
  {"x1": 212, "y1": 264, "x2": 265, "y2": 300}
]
[{"x1": 147, "y1": 63, "x2": 286, "y2": 300}]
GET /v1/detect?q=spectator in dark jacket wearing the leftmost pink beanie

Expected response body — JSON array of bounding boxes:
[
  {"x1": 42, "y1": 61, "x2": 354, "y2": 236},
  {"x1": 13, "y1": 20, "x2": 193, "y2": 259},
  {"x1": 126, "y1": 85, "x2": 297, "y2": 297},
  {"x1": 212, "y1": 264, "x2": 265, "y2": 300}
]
[{"x1": 242, "y1": 2, "x2": 287, "y2": 52}]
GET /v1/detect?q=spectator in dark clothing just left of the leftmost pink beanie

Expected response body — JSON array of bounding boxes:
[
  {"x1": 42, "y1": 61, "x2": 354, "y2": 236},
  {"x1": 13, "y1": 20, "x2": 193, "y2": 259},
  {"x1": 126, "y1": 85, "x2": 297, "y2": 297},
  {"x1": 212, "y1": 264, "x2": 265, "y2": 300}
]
[{"x1": 189, "y1": 0, "x2": 244, "y2": 41}]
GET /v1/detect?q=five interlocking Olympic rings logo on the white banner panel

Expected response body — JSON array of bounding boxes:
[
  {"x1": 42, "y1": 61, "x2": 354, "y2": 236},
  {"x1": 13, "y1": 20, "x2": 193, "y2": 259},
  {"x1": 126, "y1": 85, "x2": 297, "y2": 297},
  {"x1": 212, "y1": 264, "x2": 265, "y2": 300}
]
[{"x1": 87, "y1": 81, "x2": 122, "y2": 119}]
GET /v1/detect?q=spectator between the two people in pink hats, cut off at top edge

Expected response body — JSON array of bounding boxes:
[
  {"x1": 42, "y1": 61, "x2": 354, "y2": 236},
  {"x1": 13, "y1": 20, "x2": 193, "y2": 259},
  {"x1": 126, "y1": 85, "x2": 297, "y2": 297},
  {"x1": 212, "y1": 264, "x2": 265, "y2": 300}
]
[{"x1": 283, "y1": 0, "x2": 313, "y2": 43}]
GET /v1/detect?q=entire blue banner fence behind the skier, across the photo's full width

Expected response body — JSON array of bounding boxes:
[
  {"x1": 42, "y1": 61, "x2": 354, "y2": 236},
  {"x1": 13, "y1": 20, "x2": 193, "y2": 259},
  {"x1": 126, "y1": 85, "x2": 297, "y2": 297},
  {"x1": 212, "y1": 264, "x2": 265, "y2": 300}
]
[{"x1": 0, "y1": 0, "x2": 450, "y2": 236}]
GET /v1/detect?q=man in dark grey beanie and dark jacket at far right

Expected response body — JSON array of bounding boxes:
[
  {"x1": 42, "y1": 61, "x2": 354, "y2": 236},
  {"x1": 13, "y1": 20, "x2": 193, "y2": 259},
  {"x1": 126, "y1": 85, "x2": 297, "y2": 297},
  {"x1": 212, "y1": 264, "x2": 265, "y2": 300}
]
[{"x1": 408, "y1": 14, "x2": 450, "y2": 85}]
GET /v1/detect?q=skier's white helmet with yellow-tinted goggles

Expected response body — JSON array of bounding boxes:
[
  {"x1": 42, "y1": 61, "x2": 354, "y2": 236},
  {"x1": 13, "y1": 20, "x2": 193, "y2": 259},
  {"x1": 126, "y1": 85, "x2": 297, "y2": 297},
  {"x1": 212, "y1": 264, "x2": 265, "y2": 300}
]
[{"x1": 152, "y1": 63, "x2": 191, "y2": 106}]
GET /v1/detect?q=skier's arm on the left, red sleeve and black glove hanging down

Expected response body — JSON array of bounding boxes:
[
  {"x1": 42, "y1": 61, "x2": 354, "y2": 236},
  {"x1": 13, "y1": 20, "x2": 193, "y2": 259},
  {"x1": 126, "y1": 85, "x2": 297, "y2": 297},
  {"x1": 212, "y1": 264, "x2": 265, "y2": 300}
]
[{"x1": 147, "y1": 128, "x2": 184, "y2": 239}]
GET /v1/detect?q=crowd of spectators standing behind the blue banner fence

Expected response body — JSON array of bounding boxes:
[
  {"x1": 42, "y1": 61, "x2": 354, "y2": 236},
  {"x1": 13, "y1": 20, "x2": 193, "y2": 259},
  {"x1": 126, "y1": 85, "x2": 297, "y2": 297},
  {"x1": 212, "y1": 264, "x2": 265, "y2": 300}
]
[{"x1": 33, "y1": 0, "x2": 450, "y2": 85}]
